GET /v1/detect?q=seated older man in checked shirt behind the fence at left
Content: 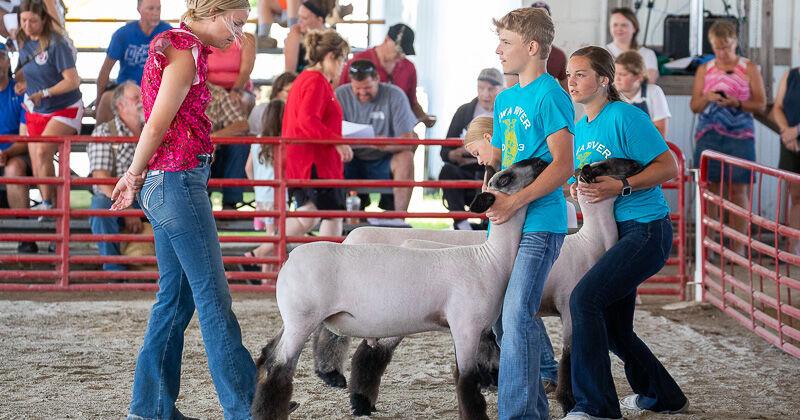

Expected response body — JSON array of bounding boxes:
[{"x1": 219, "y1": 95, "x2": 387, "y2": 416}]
[{"x1": 86, "y1": 81, "x2": 144, "y2": 271}]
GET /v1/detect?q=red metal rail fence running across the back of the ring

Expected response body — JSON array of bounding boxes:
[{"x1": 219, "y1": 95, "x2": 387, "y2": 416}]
[{"x1": 0, "y1": 136, "x2": 686, "y2": 298}]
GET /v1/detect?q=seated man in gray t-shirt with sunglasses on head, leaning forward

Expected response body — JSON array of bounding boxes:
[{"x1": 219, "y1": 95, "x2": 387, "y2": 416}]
[{"x1": 336, "y1": 60, "x2": 418, "y2": 218}]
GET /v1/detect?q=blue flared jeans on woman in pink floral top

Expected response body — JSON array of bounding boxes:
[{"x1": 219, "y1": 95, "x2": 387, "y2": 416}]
[{"x1": 129, "y1": 164, "x2": 256, "y2": 420}]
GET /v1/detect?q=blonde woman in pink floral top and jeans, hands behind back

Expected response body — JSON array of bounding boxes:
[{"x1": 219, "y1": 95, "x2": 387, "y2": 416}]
[{"x1": 111, "y1": 0, "x2": 256, "y2": 420}]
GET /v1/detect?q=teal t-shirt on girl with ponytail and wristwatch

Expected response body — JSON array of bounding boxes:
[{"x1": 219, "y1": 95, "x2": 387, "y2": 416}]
[{"x1": 575, "y1": 101, "x2": 669, "y2": 223}]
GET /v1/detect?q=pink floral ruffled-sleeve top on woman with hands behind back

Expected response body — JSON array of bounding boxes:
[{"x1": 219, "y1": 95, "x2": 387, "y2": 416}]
[{"x1": 142, "y1": 24, "x2": 214, "y2": 172}]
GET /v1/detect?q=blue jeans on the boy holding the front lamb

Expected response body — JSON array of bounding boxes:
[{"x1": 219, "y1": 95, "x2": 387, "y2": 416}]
[{"x1": 495, "y1": 232, "x2": 564, "y2": 419}]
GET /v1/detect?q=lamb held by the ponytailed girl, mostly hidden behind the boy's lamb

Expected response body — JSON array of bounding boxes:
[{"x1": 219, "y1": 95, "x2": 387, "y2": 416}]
[{"x1": 314, "y1": 159, "x2": 641, "y2": 415}]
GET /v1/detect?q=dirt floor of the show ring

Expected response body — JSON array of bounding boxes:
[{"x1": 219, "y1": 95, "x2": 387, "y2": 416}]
[{"x1": 0, "y1": 293, "x2": 800, "y2": 419}]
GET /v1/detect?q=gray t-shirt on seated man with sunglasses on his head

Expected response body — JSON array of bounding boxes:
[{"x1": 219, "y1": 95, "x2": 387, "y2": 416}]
[{"x1": 336, "y1": 83, "x2": 419, "y2": 160}]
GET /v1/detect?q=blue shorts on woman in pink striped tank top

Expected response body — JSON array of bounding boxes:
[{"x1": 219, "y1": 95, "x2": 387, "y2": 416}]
[{"x1": 694, "y1": 131, "x2": 756, "y2": 184}]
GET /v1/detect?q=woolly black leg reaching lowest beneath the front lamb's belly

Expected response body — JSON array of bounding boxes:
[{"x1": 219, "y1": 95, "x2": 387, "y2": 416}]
[{"x1": 350, "y1": 337, "x2": 403, "y2": 416}]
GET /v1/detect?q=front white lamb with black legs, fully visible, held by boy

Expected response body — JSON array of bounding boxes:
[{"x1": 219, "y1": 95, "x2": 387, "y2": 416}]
[{"x1": 252, "y1": 159, "x2": 546, "y2": 419}]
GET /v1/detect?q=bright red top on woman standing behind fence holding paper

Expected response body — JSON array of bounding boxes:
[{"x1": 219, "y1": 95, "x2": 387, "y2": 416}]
[{"x1": 282, "y1": 70, "x2": 344, "y2": 179}]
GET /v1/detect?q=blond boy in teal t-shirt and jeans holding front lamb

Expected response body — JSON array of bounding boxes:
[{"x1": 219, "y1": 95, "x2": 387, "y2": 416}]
[{"x1": 478, "y1": 7, "x2": 574, "y2": 419}]
